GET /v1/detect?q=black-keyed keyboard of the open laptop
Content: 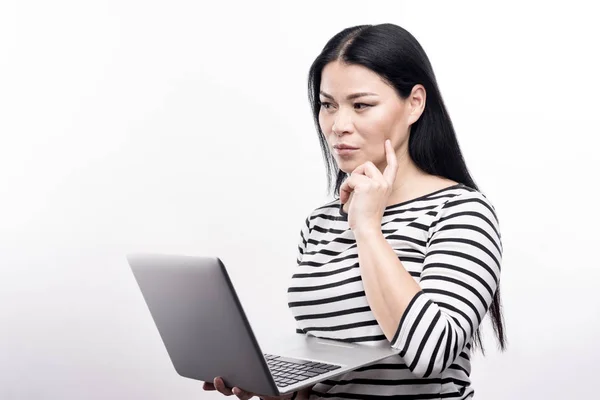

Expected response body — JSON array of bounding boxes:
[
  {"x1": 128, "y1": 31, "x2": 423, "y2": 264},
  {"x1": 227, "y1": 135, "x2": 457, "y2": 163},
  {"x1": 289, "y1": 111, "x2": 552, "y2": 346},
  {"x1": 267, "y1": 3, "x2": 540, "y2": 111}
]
[{"x1": 264, "y1": 354, "x2": 341, "y2": 387}]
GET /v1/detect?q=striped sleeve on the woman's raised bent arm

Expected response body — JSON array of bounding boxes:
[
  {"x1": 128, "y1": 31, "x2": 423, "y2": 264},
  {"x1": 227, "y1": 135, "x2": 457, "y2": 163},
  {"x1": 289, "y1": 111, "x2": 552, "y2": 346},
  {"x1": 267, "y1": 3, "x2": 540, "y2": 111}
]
[{"x1": 391, "y1": 191, "x2": 502, "y2": 377}]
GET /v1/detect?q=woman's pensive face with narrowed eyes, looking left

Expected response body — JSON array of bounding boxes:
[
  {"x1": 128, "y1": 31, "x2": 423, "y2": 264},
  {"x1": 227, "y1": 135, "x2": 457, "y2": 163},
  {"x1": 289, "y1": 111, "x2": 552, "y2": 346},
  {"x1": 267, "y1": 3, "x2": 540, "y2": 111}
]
[{"x1": 319, "y1": 61, "x2": 424, "y2": 174}]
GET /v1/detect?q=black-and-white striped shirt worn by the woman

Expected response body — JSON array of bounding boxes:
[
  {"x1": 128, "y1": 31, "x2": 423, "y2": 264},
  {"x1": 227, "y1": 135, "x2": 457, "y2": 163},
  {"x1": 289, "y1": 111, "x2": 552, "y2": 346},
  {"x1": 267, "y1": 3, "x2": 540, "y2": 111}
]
[{"x1": 288, "y1": 184, "x2": 502, "y2": 399}]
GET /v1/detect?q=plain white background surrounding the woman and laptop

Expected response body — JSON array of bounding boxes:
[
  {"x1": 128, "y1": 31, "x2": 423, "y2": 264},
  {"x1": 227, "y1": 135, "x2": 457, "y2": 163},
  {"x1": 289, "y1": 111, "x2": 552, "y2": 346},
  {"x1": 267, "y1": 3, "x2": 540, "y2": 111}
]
[{"x1": 0, "y1": 0, "x2": 600, "y2": 400}]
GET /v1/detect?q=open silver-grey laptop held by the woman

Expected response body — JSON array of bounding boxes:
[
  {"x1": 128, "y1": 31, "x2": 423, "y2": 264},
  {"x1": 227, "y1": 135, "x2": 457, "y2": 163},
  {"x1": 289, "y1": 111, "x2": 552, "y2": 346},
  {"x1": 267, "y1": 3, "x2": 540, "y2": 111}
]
[{"x1": 127, "y1": 254, "x2": 399, "y2": 396}]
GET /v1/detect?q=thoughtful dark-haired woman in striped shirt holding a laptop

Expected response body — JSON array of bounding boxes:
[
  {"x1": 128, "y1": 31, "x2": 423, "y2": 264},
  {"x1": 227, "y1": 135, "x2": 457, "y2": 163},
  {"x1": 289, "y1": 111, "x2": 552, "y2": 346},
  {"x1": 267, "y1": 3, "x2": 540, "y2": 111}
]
[{"x1": 205, "y1": 24, "x2": 506, "y2": 399}]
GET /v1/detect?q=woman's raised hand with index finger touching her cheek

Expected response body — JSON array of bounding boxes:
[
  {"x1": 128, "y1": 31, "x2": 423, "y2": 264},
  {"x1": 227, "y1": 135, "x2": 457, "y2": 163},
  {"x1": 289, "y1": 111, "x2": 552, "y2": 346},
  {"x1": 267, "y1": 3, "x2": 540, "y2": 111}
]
[{"x1": 340, "y1": 140, "x2": 398, "y2": 233}]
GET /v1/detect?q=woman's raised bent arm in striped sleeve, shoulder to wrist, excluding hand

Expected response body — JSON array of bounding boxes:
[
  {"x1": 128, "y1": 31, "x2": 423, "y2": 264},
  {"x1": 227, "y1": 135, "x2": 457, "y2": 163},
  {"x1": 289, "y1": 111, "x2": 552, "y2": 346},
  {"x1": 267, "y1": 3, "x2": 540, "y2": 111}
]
[{"x1": 356, "y1": 192, "x2": 502, "y2": 377}]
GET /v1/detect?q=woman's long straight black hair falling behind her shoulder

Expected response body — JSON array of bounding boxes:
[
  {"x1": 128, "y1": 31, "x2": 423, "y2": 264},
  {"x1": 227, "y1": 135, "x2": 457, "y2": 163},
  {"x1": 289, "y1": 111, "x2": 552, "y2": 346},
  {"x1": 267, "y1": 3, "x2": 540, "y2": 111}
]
[{"x1": 308, "y1": 24, "x2": 506, "y2": 351}]
